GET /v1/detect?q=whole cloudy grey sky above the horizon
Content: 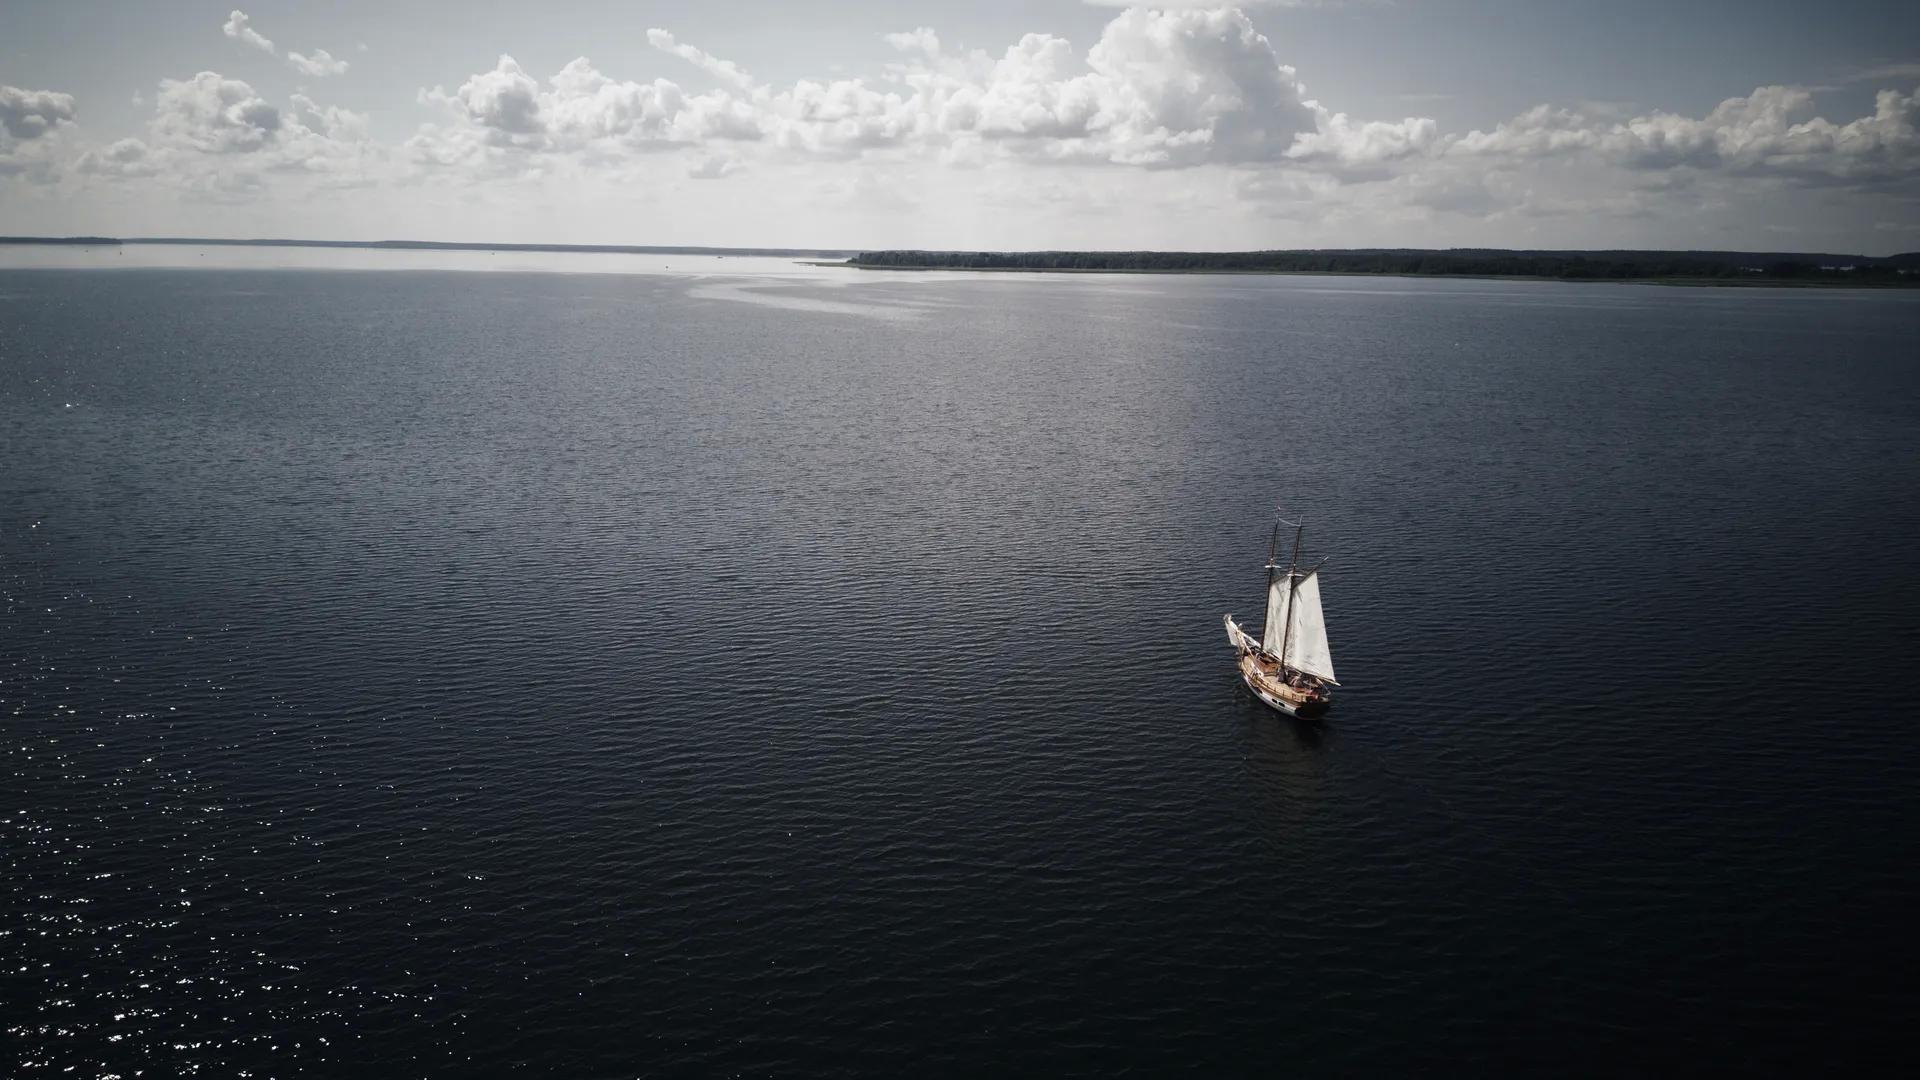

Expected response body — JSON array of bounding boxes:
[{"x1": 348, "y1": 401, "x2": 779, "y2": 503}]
[{"x1": 0, "y1": 0, "x2": 1920, "y2": 254}]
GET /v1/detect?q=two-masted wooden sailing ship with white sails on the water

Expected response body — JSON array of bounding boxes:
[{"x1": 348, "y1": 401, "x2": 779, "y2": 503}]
[{"x1": 1227, "y1": 519, "x2": 1340, "y2": 719}]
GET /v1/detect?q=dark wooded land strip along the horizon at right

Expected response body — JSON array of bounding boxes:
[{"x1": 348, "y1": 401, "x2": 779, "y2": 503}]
[{"x1": 849, "y1": 248, "x2": 1920, "y2": 286}]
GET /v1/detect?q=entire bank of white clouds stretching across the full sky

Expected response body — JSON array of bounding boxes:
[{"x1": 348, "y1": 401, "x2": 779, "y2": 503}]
[{"x1": 0, "y1": 6, "x2": 1920, "y2": 246}]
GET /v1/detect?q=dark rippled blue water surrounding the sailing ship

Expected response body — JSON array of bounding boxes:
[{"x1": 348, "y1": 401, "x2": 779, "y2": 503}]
[{"x1": 0, "y1": 269, "x2": 1920, "y2": 1076}]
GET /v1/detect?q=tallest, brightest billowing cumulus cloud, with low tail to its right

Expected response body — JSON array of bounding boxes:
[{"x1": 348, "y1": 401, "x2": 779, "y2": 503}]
[{"x1": 810, "y1": 8, "x2": 1382, "y2": 167}]
